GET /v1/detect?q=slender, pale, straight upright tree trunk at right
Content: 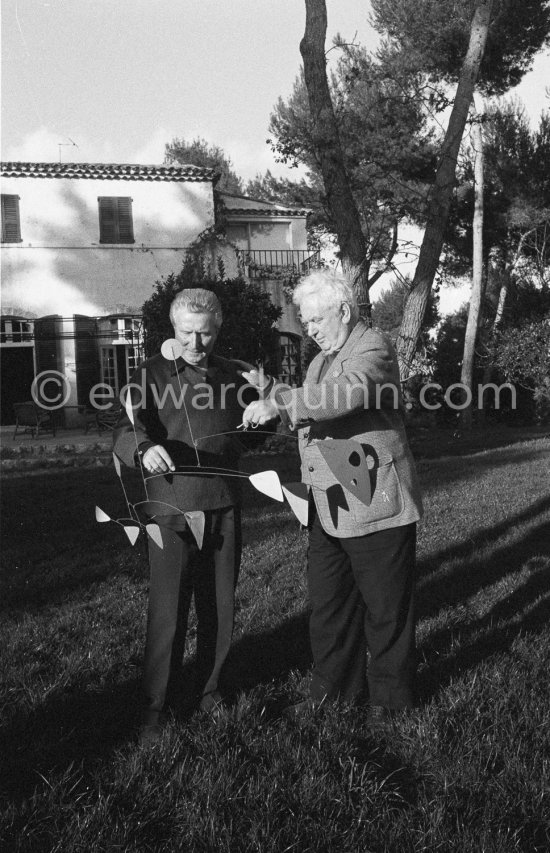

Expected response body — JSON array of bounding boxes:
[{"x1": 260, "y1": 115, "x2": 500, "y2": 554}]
[{"x1": 460, "y1": 113, "x2": 483, "y2": 429}]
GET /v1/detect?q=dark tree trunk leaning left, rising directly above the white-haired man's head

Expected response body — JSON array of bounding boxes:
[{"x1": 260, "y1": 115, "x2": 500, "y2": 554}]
[{"x1": 300, "y1": 0, "x2": 369, "y2": 313}]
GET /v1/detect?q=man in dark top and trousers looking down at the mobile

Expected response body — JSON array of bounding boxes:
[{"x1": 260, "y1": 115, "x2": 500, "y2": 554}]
[{"x1": 114, "y1": 288, "x2": 255, "y2": 744}]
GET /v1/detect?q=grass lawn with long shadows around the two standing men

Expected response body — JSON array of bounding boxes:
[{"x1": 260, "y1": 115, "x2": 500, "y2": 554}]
[{"x1": 0, "y1": 438, "x2": 550, "y2": 853}]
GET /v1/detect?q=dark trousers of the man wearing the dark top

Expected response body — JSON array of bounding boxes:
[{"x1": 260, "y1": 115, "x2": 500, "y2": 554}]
[{"x1": 142, "y1": 507, "x2": 241, "y2": 711}]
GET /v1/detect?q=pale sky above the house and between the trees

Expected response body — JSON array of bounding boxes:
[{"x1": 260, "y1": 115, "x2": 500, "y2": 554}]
[{"x1": 1, "y1": 0, "x2": 550, "y2": 310}]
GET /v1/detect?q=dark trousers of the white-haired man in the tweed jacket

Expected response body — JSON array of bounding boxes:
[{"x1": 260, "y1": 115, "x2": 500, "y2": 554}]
[{"x1": 308, "y1": 515, "x2": 416, "y2": 709}]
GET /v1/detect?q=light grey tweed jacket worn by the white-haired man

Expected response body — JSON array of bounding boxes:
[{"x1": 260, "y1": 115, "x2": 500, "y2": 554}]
[{"x1": 274, "y1": 320, "x2": 422, "y2": 538}]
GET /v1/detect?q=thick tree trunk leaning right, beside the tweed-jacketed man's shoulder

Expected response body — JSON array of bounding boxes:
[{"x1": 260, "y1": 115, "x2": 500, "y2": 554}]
[{"x1": 397, "y1": 0, "x2": 493, "y2": 379}]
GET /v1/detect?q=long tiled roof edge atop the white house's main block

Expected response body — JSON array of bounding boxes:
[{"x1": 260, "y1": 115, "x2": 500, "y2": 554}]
[{"x1": 0, "y1": 162, "x2": 217, "y2": 181}]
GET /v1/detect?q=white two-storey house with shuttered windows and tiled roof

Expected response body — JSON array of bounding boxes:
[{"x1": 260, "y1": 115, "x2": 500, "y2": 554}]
[{"x1": 0, "y1": 163, "x2": 314, "y2": 426}]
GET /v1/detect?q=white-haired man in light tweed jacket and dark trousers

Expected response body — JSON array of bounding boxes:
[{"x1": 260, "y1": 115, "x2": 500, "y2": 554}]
[{"x1": 244, "y1": 270, "x2": 422, "y2": 723}]
